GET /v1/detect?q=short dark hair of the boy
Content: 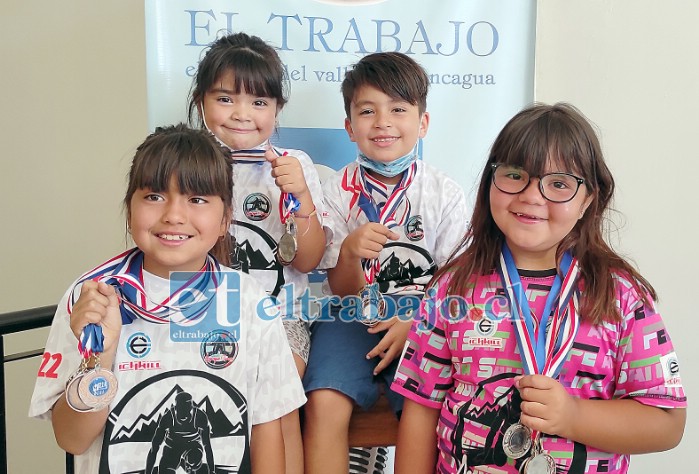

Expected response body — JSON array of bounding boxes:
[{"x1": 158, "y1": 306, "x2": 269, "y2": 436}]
[{"x1": 342, "y1": 52, "x2": 430, "y2": 118}]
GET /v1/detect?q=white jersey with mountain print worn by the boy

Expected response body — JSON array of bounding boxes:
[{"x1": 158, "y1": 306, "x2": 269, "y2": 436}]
[{"x1": 318, "y1": 160, "x2": 471, "y2": 294}]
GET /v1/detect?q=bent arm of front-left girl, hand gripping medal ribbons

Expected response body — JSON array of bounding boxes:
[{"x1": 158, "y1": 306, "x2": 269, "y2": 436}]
[{"x1": 51, "y1": 281, "x2": 121, "y2": 454}]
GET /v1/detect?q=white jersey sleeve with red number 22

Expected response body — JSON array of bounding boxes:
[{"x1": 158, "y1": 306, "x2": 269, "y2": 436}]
[{"x1": 29, "y1": 290, "x2": 81, "y2": 419}]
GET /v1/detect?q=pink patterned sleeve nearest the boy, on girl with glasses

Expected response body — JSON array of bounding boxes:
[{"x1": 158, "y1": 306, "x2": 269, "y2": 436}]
[{"x1": 391, "y1": 283, "x2": 453, "y2": 408}]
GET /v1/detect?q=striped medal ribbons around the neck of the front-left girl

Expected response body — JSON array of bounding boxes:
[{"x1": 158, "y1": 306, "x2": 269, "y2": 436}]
[{"x1": 66, "y1": 247, "x2": 221, "y2": 358}]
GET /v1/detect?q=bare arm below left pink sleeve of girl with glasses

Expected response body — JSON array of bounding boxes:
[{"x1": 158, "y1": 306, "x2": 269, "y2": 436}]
[{"x1": 395, "y1": 398, "x2": 439, "y2": 474}]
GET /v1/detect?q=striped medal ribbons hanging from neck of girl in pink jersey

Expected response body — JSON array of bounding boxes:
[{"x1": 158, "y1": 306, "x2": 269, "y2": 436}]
[{"x1": 498, "y1": 244, "x2": 580, "y2": 378}]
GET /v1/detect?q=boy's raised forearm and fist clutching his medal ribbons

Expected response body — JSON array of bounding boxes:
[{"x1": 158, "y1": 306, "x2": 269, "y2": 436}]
[{"x1": 328, "y1": 222, "x2": 399, "y2": 297}]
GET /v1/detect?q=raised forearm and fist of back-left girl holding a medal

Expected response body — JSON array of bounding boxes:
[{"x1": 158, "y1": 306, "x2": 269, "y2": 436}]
[{"x1": 265, "y1": 150, "x2": 325, "y2": 273}]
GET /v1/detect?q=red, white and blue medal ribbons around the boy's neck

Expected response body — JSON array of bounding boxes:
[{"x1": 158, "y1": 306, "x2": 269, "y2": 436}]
[{"x1": 352, "y1": 162, "x2": 417, "y2": 284}]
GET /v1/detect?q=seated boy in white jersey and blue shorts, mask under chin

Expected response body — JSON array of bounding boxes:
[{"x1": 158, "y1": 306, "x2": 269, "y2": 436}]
[{"x1": 304, "y1": 53, "x2": 468, "y2": 474}]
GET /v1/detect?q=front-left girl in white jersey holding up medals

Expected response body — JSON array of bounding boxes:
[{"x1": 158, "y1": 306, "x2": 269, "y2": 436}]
[{"x1": 29, "y1": 125, "x2": 305, "y2": 474}]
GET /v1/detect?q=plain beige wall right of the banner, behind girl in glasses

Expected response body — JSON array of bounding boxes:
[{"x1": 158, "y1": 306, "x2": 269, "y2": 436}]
[{"x1": 535, "y1": 0, "x2": 699, "y2": 474}]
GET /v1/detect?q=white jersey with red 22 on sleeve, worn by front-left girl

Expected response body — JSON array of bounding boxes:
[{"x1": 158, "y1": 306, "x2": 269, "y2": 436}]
[{"x1": 29, "y1": 268, "x2": 305, "y2": 474}]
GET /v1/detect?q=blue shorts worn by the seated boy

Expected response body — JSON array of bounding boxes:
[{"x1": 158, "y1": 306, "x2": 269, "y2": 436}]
[{"x1": 303, "y1": 313, "x2": 403, "y2": 414}]
